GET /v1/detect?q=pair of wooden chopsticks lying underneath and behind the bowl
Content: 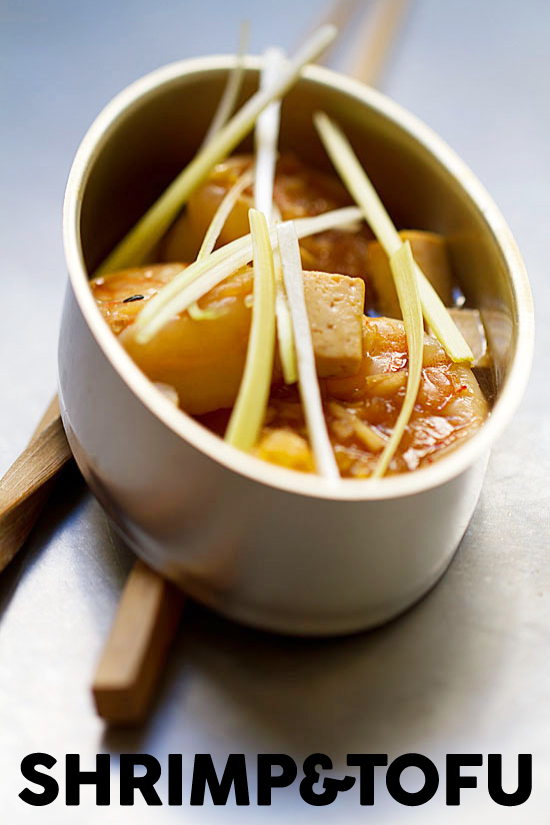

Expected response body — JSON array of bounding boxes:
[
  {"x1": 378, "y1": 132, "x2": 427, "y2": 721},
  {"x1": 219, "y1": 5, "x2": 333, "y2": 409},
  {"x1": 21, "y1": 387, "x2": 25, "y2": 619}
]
[{"x1": 0, "y1": 0, "x2": 408, "y2": 724}]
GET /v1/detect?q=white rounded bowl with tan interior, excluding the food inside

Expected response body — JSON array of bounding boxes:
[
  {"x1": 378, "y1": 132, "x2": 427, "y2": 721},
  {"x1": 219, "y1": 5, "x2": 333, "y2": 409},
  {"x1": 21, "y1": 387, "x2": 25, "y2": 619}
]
[{"x1": 59, "y1": 57, "x2": 533, "y2": 634}]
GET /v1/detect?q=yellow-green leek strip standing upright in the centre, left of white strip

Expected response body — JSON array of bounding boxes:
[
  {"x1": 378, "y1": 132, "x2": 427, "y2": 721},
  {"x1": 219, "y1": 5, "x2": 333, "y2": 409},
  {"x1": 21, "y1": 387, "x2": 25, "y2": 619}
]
[{"x1": 225, "y1": 209, "x2": 275, "y2": 451}]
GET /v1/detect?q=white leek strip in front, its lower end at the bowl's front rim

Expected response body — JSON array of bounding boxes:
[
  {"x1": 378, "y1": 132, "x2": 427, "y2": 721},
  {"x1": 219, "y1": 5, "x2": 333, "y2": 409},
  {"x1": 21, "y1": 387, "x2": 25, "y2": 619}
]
[{"x1": 277, "y1": 221, "x2": 340, "y2": 479}]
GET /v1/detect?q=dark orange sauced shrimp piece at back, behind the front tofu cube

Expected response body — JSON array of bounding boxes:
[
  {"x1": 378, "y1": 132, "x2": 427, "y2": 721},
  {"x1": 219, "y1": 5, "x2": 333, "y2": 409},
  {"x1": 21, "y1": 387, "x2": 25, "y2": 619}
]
[{"x1": 160, "y1": 154, "x2": 372, "y2": 303}]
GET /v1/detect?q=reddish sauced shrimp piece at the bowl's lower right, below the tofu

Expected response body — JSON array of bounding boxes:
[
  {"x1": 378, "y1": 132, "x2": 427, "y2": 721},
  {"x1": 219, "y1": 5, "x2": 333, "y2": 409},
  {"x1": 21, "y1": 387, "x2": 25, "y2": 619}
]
[{"x1": 324, "y1": 318, "x2": 488, "y2": 476}]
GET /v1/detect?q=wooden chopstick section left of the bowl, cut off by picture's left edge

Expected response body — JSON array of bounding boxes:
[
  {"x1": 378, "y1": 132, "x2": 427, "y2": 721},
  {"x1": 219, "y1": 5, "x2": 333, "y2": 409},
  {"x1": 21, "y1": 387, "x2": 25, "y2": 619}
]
[{"x1": 0, "y1": 397, "x2": 71, "y2": 572}]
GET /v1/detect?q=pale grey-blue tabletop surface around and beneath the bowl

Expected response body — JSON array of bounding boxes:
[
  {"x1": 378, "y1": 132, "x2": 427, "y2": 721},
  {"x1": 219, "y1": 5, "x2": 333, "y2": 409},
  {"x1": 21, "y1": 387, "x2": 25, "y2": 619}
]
[{"x1": 0, "y1": 0, "x2": 550, "y2": 825}]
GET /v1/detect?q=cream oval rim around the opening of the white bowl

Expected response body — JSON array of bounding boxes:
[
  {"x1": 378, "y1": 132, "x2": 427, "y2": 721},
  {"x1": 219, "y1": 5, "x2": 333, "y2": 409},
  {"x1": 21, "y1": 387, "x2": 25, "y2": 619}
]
[{"x1": 60, "y1": 55, "x2": 534, "y2": 501}]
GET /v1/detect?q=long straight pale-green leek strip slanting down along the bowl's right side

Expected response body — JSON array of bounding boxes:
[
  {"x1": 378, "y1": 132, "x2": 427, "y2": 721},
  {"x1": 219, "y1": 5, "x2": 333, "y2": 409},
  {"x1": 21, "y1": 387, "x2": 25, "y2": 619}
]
[{"x1": 314, "y1": 112, "x2": 474, "y2": 362}]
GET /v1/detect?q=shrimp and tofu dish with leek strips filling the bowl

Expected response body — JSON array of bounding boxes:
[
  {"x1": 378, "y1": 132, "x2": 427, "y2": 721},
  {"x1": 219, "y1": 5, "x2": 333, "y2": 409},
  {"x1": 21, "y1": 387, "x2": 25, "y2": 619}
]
[{"x1": 91, "y1": 29, "x2": 490, "y2": 478}]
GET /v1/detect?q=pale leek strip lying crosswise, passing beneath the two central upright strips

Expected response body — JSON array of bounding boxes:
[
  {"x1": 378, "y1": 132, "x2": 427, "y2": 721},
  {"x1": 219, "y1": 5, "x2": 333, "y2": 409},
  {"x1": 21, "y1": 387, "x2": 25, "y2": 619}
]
[{"x1": 132, "y1": 206, "x2": 361, "y2": 344}]
